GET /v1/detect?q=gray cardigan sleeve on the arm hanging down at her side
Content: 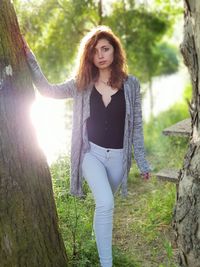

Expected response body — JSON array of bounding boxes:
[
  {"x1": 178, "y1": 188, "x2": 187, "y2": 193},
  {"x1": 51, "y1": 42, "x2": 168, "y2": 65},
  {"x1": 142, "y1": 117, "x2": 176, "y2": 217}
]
[{"x1": 133, "y1": 78, "x2": 150, "y2": 173}]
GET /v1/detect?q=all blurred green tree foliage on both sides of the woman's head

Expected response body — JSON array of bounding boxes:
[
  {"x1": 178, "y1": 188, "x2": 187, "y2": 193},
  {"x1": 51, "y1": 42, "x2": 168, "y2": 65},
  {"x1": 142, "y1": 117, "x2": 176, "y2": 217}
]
[{"x1": 14, "y1": 0, "x2": 178, "y2": 82}]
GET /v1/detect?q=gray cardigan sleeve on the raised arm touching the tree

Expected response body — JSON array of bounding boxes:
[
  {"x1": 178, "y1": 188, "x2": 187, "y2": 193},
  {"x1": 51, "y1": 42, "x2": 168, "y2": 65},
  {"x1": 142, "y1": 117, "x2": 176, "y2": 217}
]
[{"x1": 26, "y1": 51, "x2": 76, "y2": 99}]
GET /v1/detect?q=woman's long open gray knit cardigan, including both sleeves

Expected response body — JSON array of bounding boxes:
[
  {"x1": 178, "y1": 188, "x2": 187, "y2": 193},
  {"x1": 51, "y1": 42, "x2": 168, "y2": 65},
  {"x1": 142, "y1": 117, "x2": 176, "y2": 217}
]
[{"x1": 27, "y1": 51, "x2": 150, "y2": 197}]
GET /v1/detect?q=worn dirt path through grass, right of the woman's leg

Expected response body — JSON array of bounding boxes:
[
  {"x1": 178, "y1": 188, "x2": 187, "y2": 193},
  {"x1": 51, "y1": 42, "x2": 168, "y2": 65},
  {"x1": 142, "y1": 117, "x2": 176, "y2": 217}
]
[{"x1": 113, "y1": 179, "x2": 176, "y2": 267}]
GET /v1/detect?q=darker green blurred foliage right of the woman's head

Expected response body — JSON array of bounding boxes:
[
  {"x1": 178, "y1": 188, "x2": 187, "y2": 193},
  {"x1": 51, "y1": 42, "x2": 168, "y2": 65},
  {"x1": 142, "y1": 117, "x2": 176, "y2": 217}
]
[{"x1": 105, "y1": 1, "x2": 178, "y2": 82}]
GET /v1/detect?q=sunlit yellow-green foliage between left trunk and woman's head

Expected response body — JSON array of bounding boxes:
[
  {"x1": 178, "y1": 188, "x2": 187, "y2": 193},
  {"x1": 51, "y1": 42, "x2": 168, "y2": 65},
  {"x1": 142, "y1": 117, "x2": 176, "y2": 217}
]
[{"x1": 15, "y1": 0, "x2": 98, "y2": 82}]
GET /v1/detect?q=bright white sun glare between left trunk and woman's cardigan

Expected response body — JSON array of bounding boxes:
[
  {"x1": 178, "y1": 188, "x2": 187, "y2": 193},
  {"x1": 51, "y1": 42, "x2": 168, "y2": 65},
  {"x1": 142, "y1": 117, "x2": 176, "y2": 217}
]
[{"x1": 31, "y1": 94, "x2": 71, "y2": 164}]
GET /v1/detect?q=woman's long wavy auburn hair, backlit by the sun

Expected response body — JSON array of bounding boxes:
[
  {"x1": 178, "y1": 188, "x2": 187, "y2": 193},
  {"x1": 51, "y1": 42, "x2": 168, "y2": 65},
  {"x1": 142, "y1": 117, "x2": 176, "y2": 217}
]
[{"x1": 76, "y1": 26, "x2": 127, "y2": 90}]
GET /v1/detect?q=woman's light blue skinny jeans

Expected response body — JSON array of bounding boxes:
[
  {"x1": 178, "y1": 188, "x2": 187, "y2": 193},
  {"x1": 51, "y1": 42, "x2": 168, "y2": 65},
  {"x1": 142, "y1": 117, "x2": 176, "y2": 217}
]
[{"x1": 82, "y1": 142, "x2": 123, "y2": 267}]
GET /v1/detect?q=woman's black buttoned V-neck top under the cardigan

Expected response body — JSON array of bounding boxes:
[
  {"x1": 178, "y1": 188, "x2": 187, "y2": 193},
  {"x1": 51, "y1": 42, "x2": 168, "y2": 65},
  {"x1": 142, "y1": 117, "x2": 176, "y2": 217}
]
[{"x1": 87, "y1": 87, "x2": 126, "y2": 148}]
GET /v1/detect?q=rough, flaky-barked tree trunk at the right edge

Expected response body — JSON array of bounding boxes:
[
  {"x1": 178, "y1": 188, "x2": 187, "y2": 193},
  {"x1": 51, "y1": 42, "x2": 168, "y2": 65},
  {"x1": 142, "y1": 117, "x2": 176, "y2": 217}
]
[{"x1": 174, "y1": 0, "x2": 200, "y2": 267}]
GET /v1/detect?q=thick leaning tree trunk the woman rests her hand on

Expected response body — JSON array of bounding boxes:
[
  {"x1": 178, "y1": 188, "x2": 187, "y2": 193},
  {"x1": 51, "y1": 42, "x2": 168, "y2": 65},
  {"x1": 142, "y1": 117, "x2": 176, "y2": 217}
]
[{"x1": 0, "y1": 0, "x2": 67, "y2": 267}]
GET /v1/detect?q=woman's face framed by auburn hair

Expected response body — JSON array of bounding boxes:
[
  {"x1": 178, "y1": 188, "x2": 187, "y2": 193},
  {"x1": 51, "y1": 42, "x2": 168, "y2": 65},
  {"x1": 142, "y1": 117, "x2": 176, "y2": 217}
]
[{"x1": 93, "y1": 39, "x2": 114, "y2": 70}]
